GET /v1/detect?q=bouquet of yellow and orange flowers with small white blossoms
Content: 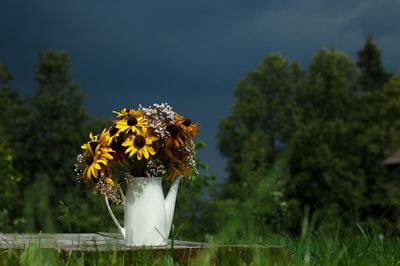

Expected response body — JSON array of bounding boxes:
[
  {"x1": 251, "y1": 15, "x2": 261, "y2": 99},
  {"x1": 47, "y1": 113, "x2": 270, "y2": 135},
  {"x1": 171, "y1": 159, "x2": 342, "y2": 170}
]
[{"x1": 75, "y1": 103, "x2": 199, "y2": 204}]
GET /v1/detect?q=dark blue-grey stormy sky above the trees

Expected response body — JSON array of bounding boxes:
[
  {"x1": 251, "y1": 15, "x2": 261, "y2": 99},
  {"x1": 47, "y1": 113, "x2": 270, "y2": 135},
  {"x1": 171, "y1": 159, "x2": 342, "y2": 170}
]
[{"x1": 0, "y1": 0, "x2": 400, "y2": 181}]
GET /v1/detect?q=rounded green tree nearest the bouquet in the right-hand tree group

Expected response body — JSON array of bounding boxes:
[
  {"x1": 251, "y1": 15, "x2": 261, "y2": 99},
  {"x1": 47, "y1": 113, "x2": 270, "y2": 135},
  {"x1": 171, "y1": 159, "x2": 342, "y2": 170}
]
[{"x1": 218, "y1": 54, "x2": 303, "y2": 233}]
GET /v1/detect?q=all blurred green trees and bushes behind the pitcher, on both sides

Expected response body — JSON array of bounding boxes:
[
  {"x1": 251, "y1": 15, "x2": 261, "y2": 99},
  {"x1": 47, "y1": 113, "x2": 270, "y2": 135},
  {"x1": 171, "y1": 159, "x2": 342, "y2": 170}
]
[{"x1": 0, "y1": 36, "x2": 400, "y2": 240}]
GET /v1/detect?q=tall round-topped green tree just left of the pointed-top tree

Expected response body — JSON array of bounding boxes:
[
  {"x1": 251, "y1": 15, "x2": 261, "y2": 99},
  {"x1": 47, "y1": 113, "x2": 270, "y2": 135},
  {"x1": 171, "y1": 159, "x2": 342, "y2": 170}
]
[{"x1": 286, "y1": 50, "x2": 365, "y2": 230}]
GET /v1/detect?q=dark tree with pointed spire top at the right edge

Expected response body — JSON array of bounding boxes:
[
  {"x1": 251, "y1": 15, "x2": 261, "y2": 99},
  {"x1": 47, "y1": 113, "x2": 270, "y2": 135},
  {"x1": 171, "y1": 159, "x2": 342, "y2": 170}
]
[{"x1": 357, "y1": 35, "x2": 400, "y2": 228}]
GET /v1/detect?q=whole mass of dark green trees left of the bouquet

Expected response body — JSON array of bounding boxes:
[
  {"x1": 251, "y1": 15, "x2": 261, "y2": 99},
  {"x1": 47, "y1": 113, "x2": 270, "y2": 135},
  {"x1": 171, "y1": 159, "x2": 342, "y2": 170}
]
[{"x1": 0, "y1": 50, "x2": 120, "y2": 232}]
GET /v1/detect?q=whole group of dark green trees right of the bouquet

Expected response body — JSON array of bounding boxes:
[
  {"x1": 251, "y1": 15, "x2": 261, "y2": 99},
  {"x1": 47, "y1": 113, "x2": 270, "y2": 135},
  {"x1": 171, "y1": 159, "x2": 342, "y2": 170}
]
[{"x1": 218, "y1": 36, "x2": 400, "y2": 232}]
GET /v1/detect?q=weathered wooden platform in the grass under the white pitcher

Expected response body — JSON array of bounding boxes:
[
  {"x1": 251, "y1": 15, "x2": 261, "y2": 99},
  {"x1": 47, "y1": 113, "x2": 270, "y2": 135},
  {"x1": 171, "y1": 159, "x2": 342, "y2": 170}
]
[{"x1": 0, "y1": 232, "x2": 291, "y2": 264}]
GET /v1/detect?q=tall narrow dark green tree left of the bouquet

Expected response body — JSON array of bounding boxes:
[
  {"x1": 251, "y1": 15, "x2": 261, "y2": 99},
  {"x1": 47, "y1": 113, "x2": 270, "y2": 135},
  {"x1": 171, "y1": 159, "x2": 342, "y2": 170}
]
[{"x1": 17, "y1": 50, "x2": 86, "y2": 232}]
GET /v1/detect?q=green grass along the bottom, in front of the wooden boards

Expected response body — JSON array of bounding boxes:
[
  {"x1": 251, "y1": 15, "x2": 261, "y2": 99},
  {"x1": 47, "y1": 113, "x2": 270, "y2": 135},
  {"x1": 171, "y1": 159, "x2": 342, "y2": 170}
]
[{"x1": 0, "y1": 227, "x2": 400, "y2": 265}]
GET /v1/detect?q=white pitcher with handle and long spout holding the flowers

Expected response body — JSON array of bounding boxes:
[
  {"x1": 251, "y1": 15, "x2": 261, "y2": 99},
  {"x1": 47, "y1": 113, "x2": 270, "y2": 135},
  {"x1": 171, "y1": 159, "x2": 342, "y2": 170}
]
[{"x1": 105, "y1": 177, "x2": 180, "y2": 246}]
